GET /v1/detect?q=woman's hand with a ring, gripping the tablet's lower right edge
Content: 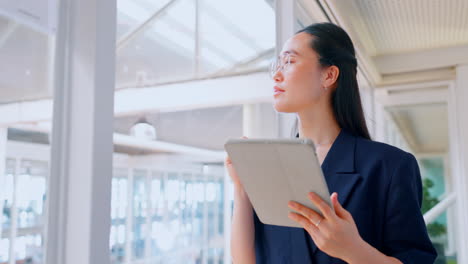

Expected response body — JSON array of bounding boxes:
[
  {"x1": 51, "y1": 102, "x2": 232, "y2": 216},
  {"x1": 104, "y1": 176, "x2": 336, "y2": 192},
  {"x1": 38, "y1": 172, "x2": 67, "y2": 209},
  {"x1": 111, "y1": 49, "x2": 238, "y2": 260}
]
[{"x1": 288, "y1": 193, "x2": 365, "y2": 261}]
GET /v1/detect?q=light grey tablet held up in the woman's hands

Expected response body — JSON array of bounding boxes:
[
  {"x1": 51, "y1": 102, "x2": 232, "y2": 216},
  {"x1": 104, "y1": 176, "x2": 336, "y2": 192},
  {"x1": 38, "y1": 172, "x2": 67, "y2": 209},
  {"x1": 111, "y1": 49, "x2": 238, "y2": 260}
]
[{"x1": 224, "y1": 139, "x2": 332, "y2": 227}]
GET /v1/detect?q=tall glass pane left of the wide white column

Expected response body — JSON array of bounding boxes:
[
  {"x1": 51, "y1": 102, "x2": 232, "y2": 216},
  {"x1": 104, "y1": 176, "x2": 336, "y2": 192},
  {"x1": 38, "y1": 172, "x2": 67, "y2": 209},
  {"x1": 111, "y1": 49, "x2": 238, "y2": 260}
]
[{"x1": 0, "y1": 1, "x2": 58, "y2": 263}]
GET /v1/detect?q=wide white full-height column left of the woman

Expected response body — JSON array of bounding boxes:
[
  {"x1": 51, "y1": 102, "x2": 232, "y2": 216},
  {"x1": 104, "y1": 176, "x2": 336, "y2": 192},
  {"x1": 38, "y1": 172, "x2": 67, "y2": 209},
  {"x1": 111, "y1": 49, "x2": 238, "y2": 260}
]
[{"x1": 46, "y1": 0, "x2": 116, "y2": 264}]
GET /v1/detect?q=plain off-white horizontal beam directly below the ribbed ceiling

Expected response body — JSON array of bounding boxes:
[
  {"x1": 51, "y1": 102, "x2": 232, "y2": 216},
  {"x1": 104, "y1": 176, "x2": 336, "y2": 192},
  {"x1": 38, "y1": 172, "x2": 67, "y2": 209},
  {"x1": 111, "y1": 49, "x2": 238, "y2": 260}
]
[{"x1": 373, "y1": 45, "x2": 468, "y2": 74}]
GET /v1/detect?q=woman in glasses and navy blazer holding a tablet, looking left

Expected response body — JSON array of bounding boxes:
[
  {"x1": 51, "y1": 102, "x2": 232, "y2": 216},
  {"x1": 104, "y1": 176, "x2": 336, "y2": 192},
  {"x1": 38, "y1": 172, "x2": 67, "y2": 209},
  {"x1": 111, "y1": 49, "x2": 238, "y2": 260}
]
[{"x1": 226, "y1": 23, "x2": 437, "y2": 264}]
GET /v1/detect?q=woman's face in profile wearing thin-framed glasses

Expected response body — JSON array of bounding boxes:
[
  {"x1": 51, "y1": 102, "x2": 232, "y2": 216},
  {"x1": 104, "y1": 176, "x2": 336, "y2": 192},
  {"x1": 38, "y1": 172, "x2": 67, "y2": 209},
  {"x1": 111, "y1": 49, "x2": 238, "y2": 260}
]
[{"x1": 273, "y1": 33, "x2": 327, "y2": 113}]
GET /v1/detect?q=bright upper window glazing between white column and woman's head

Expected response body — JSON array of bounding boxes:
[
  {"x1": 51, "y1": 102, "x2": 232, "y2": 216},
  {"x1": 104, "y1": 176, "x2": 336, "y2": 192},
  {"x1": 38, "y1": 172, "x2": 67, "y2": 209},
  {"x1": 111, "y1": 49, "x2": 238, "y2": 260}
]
[{"x1": 116, "y1": 0, "x2": 275, "y2": 88}]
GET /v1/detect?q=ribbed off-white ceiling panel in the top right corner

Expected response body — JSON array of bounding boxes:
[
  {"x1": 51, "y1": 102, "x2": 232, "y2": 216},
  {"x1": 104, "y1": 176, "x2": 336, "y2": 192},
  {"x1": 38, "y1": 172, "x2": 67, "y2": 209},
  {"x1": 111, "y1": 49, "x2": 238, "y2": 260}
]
[{"x1": 351, "y1": 0, "x2": 468, "y2": 56}]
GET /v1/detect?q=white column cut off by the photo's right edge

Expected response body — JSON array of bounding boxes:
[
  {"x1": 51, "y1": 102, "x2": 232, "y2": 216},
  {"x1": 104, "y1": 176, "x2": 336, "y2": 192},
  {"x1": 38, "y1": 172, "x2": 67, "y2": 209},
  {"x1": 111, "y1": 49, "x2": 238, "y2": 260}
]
[{"x1": 449, "y1": 65, "x2": 468, "y2": 263}]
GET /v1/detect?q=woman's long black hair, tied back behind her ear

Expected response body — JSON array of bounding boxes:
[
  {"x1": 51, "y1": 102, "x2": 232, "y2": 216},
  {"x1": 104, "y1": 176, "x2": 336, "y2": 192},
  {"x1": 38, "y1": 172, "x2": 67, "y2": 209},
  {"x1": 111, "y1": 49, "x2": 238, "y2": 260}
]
[{"x1": 294, "y1": 23, "x2": 370, "y2": 139}]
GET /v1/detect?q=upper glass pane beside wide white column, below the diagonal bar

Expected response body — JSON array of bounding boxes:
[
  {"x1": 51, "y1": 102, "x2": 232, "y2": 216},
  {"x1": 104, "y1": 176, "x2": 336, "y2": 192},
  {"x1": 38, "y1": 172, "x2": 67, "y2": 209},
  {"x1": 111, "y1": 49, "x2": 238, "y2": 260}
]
[{"x1": 116, "y1": 0, "x2": 195, "y2": 89}]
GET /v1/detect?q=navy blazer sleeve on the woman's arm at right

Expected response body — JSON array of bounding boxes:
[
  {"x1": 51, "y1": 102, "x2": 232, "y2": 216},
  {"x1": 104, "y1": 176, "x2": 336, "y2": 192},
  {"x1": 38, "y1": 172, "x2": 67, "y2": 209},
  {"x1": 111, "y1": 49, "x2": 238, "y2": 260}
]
[{"x1": 384, "y1": 153, "x2": 437, "y2": 264}]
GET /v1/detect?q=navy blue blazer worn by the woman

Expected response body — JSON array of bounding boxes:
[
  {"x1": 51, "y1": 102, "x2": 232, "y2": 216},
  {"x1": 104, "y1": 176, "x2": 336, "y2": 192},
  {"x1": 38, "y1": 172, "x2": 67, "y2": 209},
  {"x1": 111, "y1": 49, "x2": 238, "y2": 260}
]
[{"x1": 254, "y1": 129, "x2": 437, "y2": 264}]
